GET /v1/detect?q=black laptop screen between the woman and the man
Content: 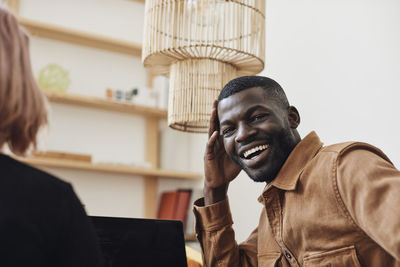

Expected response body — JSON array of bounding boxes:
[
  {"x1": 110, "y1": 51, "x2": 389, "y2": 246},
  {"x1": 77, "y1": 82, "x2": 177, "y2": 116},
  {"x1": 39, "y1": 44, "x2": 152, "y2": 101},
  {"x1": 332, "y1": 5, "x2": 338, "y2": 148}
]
[{"x1": 90, "y1": 216, "x2": 187, "y2": 267}]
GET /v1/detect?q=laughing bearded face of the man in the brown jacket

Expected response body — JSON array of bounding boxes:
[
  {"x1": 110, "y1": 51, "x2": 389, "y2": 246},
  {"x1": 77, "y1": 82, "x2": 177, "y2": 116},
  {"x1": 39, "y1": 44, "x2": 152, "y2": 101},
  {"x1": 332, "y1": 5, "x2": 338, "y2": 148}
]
[{"x1": 218, "y1": 87, "x2": 298, "y2": 182}]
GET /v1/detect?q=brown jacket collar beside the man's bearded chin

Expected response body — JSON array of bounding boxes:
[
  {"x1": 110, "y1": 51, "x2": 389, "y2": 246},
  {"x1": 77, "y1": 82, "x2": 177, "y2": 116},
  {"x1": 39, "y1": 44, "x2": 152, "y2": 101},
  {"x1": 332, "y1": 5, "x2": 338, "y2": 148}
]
[{"x1": 259, "y1": 131, "x2": 323, "y2": 202}]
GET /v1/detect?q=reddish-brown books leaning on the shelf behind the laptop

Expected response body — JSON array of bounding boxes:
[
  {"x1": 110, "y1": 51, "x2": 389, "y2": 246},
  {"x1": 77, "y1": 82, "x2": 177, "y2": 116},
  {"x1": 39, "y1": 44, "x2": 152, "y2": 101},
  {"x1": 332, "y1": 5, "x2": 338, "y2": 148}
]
[{"x1": 157, "y1": 189, "x2": 192, "y2": 229}]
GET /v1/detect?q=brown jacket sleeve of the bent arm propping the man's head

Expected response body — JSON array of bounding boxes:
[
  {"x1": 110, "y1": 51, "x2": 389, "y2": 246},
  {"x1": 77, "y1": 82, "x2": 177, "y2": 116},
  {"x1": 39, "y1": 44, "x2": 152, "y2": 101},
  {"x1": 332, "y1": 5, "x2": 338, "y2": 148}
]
[{"x1": 194, "y1": 198, "x2": 257, "y2": 267}]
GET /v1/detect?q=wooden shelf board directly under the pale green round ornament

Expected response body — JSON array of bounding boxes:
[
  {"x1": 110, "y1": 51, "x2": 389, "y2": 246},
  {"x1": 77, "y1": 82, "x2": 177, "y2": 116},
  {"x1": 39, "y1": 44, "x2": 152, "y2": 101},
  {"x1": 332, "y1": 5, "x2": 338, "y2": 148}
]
[{"x1": 43, "y1": 90, "x2": 168, "y2": 119}]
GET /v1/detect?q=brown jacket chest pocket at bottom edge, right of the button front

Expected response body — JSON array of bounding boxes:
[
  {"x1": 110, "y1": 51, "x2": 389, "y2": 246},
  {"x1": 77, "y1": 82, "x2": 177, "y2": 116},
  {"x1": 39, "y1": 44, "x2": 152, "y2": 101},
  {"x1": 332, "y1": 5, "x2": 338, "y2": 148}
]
[{"x1": 303, "y1": 246, "x2": 361, "y2": 267}]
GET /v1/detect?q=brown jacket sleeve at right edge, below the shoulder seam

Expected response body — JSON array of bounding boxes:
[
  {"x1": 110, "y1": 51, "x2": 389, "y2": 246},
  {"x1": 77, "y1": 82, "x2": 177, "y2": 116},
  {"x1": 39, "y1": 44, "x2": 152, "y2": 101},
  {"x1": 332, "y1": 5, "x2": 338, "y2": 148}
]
[{"x1": 337, "y1": 145, "x2": 400, "y2": 261}]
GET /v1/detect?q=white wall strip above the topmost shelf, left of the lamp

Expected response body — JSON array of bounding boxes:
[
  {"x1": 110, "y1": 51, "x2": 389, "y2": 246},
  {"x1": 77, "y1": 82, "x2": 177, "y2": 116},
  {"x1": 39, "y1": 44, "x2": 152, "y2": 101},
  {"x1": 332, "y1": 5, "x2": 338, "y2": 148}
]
[{"x1": 20, "y1": 0, "x2": 144, "y2": 43}]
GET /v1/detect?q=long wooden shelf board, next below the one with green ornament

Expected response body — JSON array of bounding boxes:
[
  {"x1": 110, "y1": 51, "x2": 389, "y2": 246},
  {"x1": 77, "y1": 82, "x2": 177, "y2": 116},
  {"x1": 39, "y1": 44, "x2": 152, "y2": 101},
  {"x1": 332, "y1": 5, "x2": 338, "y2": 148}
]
[{"x1": 18, "y1": 158, "x2": 202, "y2": 180}]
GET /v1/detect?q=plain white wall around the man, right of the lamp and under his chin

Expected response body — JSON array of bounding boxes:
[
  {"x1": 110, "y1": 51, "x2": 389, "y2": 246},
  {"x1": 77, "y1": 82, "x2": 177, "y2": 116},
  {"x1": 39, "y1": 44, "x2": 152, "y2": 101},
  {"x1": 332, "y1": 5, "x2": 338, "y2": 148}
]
[{"x1": 229, "y1": 0, "x2": 400, "y2": 244}]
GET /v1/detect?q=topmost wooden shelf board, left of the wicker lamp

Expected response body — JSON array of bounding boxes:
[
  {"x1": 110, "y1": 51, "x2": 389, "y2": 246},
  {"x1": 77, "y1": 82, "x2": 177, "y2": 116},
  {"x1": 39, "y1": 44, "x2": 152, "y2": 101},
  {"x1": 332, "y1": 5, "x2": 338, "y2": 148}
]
[{"x1": 19, "y1": 18, "x2": 142, "y2": 57}]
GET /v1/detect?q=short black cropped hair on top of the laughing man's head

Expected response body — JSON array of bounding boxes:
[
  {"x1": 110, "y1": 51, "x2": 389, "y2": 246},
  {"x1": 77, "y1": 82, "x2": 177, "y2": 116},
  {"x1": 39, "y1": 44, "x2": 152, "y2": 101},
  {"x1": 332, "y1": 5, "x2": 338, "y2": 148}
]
[{"x1": 218, "y1": 76, "x2": 289, "y2": 108}]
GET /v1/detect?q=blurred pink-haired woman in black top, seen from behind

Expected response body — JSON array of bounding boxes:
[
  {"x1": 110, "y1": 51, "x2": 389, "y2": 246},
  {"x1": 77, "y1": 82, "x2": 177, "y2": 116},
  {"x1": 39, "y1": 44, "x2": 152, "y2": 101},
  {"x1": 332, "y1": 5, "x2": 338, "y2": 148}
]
[{"x1": 0, "y1": 4, "x2": 100, "y2": 267}]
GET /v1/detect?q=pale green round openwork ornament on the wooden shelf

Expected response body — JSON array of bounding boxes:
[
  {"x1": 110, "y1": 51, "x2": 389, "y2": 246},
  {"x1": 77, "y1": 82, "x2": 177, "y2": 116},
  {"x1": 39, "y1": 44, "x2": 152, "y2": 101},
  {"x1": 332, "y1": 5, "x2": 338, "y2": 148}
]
[{"x1": 38, "y1": 63, "x2": 71, "y2": 92}]
